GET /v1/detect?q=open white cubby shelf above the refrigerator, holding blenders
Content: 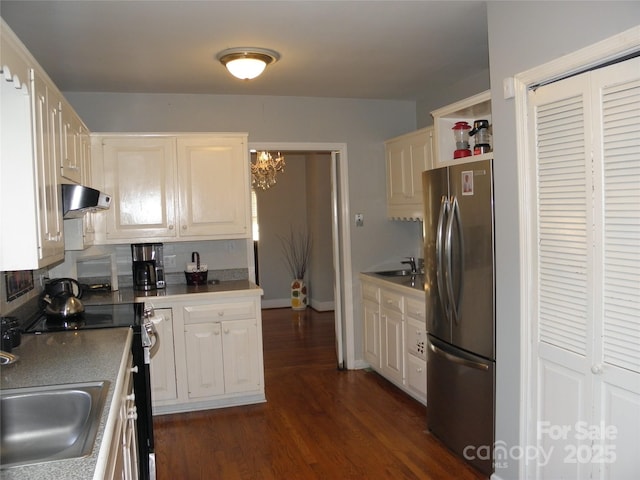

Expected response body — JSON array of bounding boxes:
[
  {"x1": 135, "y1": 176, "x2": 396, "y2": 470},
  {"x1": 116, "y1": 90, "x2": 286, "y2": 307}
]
[{"x1": 431, "y1": 90, "x2": 493, "y2": 168}]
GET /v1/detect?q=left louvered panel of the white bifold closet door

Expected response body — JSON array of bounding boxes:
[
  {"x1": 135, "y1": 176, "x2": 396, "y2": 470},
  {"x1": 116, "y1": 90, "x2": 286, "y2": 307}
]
[{"x1": 530, "y1": 75, "x2": 594, "y2": 479}]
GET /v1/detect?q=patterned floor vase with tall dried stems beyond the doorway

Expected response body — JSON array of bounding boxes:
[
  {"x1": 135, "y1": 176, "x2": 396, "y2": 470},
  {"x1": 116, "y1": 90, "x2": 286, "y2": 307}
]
[{"x1": 278, "y1": 228, "x2": 313, "y2": 310}]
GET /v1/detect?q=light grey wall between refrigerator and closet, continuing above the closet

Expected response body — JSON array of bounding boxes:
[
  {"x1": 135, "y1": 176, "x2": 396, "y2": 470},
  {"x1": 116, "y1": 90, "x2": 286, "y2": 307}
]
[{"x1": 488, "y1": 2, "x2": 640, "y2": 479}]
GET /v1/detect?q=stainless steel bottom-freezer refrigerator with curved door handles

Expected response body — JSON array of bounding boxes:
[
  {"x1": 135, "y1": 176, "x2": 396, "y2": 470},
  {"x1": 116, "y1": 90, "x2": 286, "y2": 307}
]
[{"x1": 422, "y1": 160, "x2": 495, "y2": 475}]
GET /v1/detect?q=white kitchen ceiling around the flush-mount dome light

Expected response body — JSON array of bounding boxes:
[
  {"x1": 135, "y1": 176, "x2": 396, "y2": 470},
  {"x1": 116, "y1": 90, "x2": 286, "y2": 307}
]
[{"x1": 0, "y1": 0, "x2": 489, "y2": 100}]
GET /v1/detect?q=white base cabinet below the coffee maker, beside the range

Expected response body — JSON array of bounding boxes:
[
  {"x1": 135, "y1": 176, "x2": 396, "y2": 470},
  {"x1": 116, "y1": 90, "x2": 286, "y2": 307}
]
[{"x1": 145, "y1": 289, "x2": 265, "y2": 414}]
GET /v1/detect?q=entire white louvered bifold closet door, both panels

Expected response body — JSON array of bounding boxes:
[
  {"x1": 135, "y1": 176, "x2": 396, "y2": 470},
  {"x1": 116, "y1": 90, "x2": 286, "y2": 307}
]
[{"x1": 529, "y1": 59, "x2": 640, "y2": 479}]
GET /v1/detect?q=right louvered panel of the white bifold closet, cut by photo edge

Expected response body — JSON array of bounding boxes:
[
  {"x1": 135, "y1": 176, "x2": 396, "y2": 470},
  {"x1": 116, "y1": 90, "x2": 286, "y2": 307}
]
[{"x1": 591, "y1": 58, "x2": 640, "y2": 479}]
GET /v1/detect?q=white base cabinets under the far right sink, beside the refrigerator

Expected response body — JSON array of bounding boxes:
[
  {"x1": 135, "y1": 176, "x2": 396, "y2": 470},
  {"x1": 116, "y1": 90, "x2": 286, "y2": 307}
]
[{"x1": 360, "y1": 274, "x2": 427, "y2": 405}]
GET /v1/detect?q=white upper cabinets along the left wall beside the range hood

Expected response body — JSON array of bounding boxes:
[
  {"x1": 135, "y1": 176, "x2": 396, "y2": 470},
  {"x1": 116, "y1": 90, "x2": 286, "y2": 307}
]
[{"x1": 0, "y1": 21, "x2": 89, "y2": 270}]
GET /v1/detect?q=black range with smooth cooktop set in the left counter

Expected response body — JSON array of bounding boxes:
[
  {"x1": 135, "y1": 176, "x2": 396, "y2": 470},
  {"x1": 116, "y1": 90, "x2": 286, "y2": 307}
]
[{"x1": 25, "y1": 303, "x2": 160, "y2": 480}]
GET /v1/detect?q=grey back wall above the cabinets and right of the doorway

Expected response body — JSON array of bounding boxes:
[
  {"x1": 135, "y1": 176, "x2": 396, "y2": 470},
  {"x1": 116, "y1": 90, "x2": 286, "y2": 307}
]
[{"x1": 64, "y1": 92, "x2": 421, "y2": 360}]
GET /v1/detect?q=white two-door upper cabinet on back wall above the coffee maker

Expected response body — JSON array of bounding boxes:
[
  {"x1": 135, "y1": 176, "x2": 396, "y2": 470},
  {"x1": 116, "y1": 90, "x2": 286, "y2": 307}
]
[{"x1": 93, "y1": 134, "x2": 250, "y2": 243}]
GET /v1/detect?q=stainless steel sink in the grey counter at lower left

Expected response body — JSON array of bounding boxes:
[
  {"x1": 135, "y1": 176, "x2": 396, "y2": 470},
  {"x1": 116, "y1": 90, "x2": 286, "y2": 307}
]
[{"x1": 0, "y1": 382, "x2": 109, "y2": 468}]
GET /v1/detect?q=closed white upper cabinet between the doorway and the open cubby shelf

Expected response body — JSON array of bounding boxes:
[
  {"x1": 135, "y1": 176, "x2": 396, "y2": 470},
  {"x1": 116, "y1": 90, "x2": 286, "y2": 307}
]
[{"x1": 385, "y1": 127, "x2": 433, "y2": 220}]
